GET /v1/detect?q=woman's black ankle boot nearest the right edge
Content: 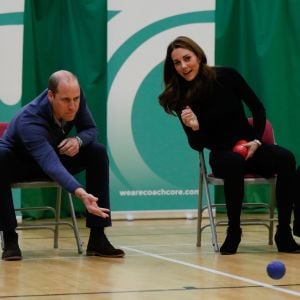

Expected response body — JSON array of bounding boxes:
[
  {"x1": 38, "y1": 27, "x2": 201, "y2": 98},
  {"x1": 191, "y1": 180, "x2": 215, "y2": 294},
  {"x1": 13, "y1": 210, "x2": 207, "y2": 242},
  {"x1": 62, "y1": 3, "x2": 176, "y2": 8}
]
[{"x1": 274, "y1": 226, "x2": 300, "y2": 253}]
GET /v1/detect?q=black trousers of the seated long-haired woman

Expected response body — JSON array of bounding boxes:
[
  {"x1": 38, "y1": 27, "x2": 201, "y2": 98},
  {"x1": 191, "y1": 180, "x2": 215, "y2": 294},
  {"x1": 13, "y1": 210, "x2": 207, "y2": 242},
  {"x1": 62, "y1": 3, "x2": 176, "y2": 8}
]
[{"x1": 210, "y1": 144, "x2": 300, "y2": 227}]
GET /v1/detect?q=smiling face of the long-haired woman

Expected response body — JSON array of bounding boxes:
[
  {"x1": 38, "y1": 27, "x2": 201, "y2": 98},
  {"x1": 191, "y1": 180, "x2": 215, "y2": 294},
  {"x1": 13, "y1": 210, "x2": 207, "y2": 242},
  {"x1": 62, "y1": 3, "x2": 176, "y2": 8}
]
[{"x1": 171, "y1": 48, "x2": 200, "y2": 81}]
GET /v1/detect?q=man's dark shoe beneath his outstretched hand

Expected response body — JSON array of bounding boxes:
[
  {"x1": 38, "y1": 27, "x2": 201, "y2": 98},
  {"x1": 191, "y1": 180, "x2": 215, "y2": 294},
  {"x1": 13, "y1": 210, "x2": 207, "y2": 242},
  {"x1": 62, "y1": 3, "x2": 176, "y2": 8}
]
[{"x1": 86, "y1": 228, "x2": 125, "y2": 257}]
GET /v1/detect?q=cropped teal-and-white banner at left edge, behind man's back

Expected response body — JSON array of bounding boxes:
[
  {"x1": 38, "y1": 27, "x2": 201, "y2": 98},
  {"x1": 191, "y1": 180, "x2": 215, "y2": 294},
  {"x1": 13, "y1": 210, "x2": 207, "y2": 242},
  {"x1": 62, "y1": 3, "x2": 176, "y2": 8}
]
[{"x1": 0, "y1": 0, "x2": 24, "y2": 215}]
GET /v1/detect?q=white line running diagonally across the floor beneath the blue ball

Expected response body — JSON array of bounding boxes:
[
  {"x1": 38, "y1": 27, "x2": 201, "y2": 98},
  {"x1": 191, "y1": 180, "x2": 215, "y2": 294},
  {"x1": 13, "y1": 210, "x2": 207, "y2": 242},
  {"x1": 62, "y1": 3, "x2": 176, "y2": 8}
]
[{"x1": 123, "y1": 247, "x2": 300, "y2": 297}]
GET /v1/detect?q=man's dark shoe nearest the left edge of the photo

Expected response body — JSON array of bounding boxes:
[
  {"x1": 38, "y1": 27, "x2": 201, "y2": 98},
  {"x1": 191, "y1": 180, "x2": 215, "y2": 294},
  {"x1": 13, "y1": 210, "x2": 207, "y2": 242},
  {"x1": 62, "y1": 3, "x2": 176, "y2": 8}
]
[{"x1": 2, "y1": 230, "x2": 22, "y2": 260}]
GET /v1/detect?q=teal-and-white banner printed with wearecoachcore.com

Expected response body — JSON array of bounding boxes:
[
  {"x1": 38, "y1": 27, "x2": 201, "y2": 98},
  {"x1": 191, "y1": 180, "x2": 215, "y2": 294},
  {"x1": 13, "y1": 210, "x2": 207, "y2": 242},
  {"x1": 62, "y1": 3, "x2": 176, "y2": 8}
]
[{"x1": 107, "y1": 0, "x2": 214, "y2": 213}]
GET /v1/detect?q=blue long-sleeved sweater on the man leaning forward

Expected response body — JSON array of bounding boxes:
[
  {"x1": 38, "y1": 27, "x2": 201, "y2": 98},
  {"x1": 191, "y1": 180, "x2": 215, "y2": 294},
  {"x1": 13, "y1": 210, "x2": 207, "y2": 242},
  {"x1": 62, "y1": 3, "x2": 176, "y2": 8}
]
[{"x1": 0, "y1": 90, "x2": 97, "y2": 193}]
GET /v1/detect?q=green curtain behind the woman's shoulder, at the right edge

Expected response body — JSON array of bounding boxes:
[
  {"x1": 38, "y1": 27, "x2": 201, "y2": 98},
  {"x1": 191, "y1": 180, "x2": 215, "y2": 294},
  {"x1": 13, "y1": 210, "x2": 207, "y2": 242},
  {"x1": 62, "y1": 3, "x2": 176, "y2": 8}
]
[{"x1": 215, "y1": 0, "x2": 300, "y2": 206}]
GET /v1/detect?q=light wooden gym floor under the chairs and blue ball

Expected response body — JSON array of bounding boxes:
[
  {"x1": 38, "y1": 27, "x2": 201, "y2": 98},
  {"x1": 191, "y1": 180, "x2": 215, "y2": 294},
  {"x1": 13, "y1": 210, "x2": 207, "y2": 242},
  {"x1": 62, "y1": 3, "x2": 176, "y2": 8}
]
[{"x1": 0, "y1": 214, "x2": 300, "y2": 300}]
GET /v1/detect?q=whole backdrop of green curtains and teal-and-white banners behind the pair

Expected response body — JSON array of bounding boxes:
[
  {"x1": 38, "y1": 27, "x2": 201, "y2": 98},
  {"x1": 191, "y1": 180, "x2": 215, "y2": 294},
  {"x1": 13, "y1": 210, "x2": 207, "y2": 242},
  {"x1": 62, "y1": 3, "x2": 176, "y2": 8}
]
[{"x1": 0, "y1": 0, "x2": 300, "y2": 218}]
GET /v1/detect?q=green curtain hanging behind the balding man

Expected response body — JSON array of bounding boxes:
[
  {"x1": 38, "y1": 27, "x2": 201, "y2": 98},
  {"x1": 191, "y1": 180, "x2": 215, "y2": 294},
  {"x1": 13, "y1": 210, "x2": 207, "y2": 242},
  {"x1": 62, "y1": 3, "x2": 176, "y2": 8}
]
[{"x1": 22, "y1": 0, "x2": 107, "y2": 217}]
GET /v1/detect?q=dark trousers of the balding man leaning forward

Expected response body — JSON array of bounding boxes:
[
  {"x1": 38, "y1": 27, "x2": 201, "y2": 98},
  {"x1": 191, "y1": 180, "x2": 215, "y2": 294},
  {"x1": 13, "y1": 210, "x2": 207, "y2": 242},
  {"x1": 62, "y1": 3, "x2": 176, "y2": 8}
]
[{"x1": 0, "y1": 143, "x2": 111, "y2": 231}]
